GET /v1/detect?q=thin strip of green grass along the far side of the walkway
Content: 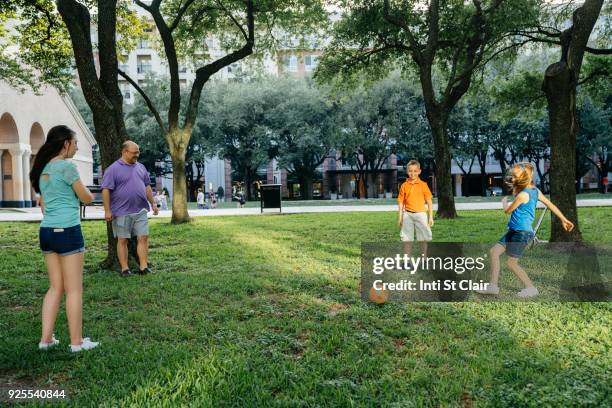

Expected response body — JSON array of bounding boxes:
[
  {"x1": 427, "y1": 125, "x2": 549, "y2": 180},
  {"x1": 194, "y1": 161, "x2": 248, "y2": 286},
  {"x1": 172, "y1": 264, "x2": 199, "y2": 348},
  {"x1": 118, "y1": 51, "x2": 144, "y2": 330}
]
[{"x1": 188, "y1": 193, "x2": 612, "y2": 209}]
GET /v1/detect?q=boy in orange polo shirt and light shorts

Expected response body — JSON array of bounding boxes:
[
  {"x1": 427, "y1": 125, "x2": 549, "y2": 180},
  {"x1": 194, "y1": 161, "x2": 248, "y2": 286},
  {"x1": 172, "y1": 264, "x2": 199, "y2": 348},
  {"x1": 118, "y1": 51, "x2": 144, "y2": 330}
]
[{"x1": 397, "y1": 160, "x2": 433, "y2": 245}]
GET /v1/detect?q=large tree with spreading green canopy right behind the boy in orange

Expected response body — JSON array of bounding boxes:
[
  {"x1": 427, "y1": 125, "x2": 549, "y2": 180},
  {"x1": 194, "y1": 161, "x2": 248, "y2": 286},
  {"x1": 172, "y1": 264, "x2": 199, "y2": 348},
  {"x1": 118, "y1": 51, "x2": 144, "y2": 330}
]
[{"x1": 319, "y1": 0, "x2": 537, "y2": 218}]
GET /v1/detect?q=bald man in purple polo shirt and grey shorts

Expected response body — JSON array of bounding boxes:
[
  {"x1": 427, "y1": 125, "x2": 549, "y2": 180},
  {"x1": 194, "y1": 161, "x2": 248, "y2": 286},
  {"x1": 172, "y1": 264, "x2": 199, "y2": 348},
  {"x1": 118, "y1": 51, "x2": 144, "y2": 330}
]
[{"x1": 102, "y1": 140, "x2": 159, "y2": 277}]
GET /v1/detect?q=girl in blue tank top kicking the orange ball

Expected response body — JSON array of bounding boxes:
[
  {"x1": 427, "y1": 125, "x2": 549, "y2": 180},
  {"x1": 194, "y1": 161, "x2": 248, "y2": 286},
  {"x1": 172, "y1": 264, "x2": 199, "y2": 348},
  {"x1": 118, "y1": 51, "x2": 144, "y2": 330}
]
[{"x1": 476, "y1": 163, "x2": 574, "y2": 298}]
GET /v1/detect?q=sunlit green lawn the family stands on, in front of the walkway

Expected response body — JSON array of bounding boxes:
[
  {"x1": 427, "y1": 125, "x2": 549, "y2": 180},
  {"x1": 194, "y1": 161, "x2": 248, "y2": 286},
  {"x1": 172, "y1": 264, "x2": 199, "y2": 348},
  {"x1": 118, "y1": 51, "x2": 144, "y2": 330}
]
[{"x1": 0, "y1": 208, "x2": 612, "y2": 407}]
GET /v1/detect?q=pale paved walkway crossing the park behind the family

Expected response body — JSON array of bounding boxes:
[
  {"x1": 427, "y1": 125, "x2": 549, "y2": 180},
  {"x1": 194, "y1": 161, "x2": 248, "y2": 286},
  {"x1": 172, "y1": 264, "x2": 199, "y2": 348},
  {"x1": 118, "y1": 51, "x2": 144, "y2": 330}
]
[{"x1": 0, "y1": 199, "x2": 612, "y2": 221}]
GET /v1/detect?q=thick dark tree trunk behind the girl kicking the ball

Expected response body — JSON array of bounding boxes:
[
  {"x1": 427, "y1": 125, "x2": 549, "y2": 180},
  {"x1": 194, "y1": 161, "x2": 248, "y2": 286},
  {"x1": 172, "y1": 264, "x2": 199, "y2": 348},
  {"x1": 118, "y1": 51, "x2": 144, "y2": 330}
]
[{"x1": 543, "y1": 61, "x2": 582, "y2": 242}]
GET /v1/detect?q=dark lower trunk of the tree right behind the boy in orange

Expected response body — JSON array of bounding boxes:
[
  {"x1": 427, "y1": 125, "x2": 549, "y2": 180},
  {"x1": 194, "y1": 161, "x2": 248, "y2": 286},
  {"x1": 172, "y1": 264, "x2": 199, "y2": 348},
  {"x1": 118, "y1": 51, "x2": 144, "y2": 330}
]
[{"x1": 427, "y1": 112, "x2": 457, "y2": 218}]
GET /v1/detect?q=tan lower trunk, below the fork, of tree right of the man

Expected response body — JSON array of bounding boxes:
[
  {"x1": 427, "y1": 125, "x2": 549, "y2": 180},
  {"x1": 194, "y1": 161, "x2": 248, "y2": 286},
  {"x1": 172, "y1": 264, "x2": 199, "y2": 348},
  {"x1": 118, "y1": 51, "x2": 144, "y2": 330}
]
[{"x1": 166, "y1": 131, "x2": 190, "y2": 224}]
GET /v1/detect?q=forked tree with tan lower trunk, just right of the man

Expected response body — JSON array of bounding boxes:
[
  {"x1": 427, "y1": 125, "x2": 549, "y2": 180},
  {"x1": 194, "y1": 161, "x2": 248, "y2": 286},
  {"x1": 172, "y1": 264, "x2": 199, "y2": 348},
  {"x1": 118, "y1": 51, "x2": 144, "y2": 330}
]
[{"x1": 119, "y1": 0, "x2": 325, "y2": 223}]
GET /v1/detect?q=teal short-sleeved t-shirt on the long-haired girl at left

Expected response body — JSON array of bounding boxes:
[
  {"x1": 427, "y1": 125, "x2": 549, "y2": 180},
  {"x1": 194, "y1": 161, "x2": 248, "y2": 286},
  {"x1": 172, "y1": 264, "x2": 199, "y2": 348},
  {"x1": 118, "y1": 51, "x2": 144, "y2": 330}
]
[{"x1": 39, "y1": 160, "x2": 81, "y2": 228}]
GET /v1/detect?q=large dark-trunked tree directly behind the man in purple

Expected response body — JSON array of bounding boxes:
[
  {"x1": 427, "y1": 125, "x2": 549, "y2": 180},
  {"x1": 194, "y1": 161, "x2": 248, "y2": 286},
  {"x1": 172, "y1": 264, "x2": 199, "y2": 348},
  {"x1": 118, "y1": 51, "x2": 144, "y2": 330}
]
[{"x1": 0, "y1": 0, "x2": 148, "y2": 268}]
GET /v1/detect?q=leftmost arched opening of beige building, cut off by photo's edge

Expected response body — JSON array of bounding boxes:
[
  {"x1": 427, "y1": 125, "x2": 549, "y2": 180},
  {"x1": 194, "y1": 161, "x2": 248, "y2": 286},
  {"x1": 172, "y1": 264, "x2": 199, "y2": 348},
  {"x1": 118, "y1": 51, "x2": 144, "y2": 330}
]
[{"x1": 0, "y1": 112, "x2": 23, "y2": 207}]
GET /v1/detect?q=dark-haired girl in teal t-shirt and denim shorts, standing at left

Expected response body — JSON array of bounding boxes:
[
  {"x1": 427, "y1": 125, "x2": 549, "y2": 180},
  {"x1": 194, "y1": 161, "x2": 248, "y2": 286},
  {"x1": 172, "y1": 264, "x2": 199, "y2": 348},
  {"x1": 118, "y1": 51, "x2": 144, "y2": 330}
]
[{"x1": 30, "y1": 126, "x2": 99, "y2": 352}]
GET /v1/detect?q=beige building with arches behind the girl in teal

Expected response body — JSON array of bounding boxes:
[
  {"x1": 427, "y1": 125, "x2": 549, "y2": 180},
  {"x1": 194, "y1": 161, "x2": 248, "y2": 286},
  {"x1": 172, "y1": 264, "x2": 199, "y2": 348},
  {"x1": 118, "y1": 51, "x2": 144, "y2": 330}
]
[{"x1": 0, "y1": 81, "x2": 96, "y2": 208}]
